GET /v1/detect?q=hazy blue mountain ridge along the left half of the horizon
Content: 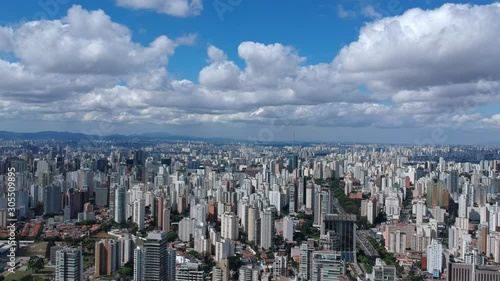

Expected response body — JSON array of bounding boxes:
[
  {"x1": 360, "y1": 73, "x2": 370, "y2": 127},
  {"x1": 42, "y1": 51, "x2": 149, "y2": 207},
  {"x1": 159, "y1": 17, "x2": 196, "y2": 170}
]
[{"x1": 0, "y1": 131, "x2": 237, "y2": 142}]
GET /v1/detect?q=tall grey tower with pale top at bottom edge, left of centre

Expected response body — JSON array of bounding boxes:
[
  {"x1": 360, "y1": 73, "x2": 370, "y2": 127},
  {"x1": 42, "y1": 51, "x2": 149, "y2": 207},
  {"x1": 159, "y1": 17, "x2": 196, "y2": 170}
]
[{"x1": 144, "y1": 231, "x2": 167, "y2": 281}]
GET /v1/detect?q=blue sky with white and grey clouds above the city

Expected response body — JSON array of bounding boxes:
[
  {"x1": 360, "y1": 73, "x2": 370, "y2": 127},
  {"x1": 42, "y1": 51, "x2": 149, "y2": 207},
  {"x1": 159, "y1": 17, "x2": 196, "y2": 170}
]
[{"x1": 0, "y1": 0, "x2": 500, "y2": 144}]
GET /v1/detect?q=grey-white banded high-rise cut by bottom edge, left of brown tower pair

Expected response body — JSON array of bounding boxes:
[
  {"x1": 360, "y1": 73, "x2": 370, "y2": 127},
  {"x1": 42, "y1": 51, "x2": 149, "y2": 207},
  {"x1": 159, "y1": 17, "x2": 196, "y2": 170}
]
[{"x1": 56, "y1": 247, "x2": 83, "y2": 281}]
